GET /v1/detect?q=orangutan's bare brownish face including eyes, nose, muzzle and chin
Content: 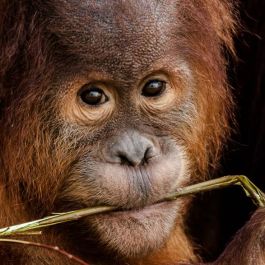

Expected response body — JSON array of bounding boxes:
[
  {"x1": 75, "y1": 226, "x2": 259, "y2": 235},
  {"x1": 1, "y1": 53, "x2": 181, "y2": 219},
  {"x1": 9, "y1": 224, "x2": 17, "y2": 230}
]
[{"x1": 54, "y1": 2, "x2": 192, "y2": 257}]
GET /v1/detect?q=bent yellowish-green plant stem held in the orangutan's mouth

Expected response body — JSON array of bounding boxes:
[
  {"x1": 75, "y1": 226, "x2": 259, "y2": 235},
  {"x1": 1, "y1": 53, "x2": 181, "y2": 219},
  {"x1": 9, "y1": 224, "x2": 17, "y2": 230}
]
[{"x1": 0, "y1": 175, "x2": 265, "y2": 237}]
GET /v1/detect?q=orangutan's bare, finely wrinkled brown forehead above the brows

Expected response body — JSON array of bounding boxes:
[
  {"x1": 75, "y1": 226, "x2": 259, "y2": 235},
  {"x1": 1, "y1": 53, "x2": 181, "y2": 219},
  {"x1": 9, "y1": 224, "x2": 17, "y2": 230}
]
[{"x1": 47, "y1": 0, "x2": 177, "y2": 74}]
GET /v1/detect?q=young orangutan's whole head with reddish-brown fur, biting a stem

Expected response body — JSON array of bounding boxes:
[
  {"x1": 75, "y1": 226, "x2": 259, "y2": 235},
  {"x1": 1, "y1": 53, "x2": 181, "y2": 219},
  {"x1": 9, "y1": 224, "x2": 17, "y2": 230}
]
[{"x1": 0, "y1": 0, "x2": 234, "y2": 265}]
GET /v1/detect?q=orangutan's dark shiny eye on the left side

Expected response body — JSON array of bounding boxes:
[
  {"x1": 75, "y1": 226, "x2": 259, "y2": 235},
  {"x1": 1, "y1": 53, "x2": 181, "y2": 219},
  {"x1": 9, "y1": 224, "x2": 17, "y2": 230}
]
[{"x1": 79, "y1": 85, "x2": 109, "y2": 106}]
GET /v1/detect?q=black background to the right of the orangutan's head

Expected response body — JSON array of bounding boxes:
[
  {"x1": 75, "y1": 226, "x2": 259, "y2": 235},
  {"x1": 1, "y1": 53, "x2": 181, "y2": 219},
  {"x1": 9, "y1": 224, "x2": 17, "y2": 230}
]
[{"x1": 189, "y1": 0, "x2": 265, "y2": 260}]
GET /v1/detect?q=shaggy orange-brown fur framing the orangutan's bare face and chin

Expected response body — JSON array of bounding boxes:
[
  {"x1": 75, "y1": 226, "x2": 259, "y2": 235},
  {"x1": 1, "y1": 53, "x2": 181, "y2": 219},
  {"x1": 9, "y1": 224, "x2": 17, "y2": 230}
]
[{"x1": 0, "y1": 0, "x2": 236, "y2": 265}]
